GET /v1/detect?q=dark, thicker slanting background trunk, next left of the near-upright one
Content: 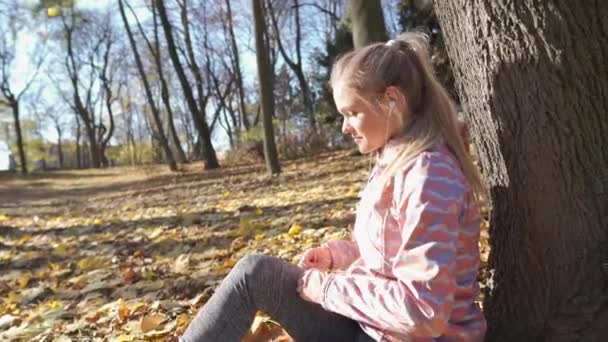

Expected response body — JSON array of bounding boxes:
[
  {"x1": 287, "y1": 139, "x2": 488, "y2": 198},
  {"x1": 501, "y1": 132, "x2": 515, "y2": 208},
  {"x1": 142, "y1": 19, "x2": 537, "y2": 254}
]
[{"x1": 154, "y1": 0, "x2": 220, "y2": 169}]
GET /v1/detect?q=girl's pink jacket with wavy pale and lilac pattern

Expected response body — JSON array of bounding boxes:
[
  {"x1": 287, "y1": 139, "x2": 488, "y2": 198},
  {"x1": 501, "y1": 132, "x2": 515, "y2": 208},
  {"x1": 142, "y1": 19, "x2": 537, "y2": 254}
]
[{"x1": 304, "y1": 140, "x2": 486, "y2": 342}]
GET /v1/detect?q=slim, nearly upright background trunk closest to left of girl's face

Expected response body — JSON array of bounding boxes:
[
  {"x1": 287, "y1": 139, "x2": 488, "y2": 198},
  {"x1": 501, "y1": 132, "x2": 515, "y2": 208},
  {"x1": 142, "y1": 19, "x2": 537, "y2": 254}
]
[{"x1": 251, "y1": 0, "x2": 281, "y2": 175}]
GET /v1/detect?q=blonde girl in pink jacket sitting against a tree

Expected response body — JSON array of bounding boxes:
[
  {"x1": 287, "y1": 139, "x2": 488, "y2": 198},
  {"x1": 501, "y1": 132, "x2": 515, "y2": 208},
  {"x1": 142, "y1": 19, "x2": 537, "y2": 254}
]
[{"x1": 180, "y1": 33, "x2": 486, "y2": 342}]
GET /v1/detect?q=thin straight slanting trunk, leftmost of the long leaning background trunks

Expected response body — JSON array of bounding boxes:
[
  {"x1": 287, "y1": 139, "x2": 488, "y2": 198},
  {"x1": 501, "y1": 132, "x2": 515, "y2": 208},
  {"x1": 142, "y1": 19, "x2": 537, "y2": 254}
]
[{"x1": 118, "y1": 0, "x2": 177, "y2": 171}]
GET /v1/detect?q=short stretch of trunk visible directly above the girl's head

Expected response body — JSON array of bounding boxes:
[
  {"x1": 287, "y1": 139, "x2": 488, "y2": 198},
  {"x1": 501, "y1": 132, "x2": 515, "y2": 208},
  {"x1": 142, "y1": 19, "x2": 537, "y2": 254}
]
[{"x1": 348, "y1": 0, "x2": 387, "y2": 48}]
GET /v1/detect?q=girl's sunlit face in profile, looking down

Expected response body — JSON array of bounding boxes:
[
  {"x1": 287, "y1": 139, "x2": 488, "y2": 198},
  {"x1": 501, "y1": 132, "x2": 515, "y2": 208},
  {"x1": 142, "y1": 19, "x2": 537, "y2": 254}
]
[{"x1": 333, "y1": 84, "x2": 401, "y2": 154}]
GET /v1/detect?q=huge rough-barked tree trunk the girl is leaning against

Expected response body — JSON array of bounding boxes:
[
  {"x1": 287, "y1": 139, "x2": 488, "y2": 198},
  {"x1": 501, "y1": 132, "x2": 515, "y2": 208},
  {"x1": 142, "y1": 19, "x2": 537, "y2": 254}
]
[{"x1": 436, "y1": 0, "x2": 608, "y2": 341}]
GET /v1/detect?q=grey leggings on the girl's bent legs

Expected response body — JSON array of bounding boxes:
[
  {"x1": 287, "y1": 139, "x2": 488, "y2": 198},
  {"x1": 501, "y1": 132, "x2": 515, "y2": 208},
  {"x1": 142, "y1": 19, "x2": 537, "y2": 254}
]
[{"x1": 180, "y1": 255, "x2": 374, "y2": 342}]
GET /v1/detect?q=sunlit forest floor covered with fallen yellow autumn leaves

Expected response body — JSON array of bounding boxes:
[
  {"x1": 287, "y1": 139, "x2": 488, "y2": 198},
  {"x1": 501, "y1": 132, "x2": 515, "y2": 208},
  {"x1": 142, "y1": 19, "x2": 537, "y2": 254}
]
[{"x1": 0, "y1": 151, "x2": 488, "y2": 341}]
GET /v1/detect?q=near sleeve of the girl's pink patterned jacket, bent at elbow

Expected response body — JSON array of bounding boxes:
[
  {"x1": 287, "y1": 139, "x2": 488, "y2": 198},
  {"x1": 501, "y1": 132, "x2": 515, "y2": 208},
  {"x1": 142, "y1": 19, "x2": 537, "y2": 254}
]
[{"x1": 321, "y1": 153, "x2": 466, "y2": 337}]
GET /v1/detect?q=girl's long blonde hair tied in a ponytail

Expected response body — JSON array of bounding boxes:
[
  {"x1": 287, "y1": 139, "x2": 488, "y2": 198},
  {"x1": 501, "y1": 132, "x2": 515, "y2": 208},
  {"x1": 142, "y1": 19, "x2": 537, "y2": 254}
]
[{"x1": 330, "y1": 32, "x2": 486, "y2": 199}]
